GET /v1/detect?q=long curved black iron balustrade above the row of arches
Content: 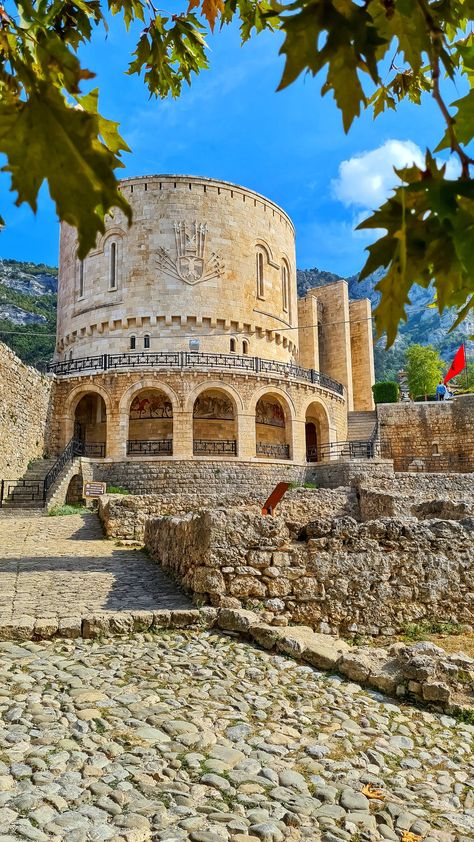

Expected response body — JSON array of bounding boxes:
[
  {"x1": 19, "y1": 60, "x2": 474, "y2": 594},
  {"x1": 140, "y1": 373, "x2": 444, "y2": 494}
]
[{"x1": 48, "y1": 351, "x2": 344, "y2": 395}]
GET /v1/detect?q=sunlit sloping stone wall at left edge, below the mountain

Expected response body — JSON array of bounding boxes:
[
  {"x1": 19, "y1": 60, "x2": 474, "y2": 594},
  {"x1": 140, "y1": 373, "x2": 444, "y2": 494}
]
[{"x1": 0, "y1": 342, "x2": 54, "y2": 479}]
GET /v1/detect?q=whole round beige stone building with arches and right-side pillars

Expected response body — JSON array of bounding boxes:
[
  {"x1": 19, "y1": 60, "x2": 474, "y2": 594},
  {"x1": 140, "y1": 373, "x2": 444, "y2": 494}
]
[{"x1": 50, "y1": 175, "x2": 374, "y2": 465}]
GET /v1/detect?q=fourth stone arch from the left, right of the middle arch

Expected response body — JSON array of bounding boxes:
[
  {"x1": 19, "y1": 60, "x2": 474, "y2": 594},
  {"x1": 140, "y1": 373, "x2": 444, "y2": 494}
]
[{"x1": 252, "y1": 386, "x2": 295, "y2": 459}]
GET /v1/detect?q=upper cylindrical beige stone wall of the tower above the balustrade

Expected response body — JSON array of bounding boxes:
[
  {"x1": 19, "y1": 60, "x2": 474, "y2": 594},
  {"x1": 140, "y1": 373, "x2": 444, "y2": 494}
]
[{"x1": 57, "y1": 176, "x2": 298, "y2": 362}]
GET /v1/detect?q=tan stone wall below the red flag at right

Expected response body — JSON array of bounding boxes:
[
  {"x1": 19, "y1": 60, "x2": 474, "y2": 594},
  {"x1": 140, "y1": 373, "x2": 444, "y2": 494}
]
[{"x1": 377, "y1": 395, "x2": 474, "y2": 473}]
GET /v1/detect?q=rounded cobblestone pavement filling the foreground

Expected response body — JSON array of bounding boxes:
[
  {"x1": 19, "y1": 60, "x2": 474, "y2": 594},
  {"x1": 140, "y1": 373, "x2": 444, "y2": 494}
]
[{"x1": 0, "y1": 631, "x2": 474, "y2": 842}]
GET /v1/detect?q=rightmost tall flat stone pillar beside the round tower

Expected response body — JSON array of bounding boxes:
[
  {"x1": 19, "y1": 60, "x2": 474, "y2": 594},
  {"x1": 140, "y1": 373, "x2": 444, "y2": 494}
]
[{"x1": 349, "y1": 298, "x2": 375, "y2": 412}]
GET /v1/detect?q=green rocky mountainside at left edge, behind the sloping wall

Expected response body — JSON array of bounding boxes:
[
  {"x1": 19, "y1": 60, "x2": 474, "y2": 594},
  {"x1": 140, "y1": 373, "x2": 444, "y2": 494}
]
[{"x1": 0, "y1": 260, "x2": 58, "y2": 368}]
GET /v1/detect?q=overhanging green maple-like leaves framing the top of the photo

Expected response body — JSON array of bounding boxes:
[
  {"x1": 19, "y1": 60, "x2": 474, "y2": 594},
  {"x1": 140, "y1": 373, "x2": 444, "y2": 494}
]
[{"x1": 0, "y1": 0, "x2": 474, "y2": 344}]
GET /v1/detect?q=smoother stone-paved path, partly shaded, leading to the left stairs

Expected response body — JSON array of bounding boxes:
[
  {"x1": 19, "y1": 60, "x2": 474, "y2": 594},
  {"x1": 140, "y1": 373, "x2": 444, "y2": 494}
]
[{"x1": 0, "y1": 514, "x2": 190, "y2": 623}]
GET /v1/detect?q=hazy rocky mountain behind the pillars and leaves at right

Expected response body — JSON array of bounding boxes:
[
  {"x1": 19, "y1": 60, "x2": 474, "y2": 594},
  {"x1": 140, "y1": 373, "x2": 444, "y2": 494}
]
[{"x1": 297, "y1": 268, "x2": 474, "y2": 380}]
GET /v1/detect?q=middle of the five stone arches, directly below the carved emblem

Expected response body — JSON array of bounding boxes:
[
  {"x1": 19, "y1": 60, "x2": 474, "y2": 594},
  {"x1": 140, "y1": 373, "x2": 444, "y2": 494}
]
[{"x1": 188, "y1": 381, "x2": 241, "y2": 457}]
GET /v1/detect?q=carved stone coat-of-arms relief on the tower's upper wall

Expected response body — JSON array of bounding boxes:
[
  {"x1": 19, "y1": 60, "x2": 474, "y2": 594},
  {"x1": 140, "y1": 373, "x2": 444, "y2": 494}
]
[{"x1": 158, "y1": 222, "x2": 224, "y2": 286}]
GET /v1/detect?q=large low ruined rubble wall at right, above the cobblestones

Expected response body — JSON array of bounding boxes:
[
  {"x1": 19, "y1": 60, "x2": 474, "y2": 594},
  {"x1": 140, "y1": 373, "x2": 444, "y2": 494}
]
[{"x1": 145, "y1": 509, "x2": 474, "y2": 635}]
